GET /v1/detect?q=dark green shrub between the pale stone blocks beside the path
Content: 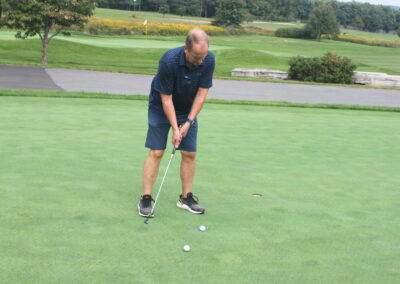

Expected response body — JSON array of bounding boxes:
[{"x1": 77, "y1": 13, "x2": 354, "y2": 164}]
[{"x1": 289, "y1": 53, "x2": 356, "y2": 84}]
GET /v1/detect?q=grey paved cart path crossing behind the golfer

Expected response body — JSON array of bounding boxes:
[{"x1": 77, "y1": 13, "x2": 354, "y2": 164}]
[{"x1": 0, "y1": 65, "x2": 400, "y2": 107}]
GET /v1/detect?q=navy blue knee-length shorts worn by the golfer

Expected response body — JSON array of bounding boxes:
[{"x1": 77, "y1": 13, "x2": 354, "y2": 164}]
[{"x1": 145, "y1": 110, "x2": 198, "y2": 152}]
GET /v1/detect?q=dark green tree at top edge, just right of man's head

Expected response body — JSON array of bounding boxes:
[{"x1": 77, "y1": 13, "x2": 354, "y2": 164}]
[{"x1": 213, "y1": 0, "x2": 244, "y2": 27}]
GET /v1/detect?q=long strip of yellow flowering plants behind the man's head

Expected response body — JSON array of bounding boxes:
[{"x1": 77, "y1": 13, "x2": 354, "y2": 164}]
[{"x1": 85, "y1": 19, "x2": 229, "y2": 35}]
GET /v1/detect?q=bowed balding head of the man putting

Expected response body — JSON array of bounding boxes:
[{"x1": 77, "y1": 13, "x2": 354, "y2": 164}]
[{"x1": 184, "y1": 28, "x2": 209, "y2": 68}]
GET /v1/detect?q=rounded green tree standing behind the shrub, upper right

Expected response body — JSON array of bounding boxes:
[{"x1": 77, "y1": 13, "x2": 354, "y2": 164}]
[{"x1": 306, "y1": 4, "x2": 340, "y2": 40}]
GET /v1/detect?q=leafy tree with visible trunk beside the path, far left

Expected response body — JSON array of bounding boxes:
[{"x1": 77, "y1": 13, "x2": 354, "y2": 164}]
[{"x1": 0, "y1": 0, "x2": 96, "y2": 64}]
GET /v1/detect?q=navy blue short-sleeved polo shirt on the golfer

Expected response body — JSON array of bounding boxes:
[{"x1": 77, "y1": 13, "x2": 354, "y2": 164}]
[{"x1": 149, "y1": 46, "x2": 215, "y2": 115}]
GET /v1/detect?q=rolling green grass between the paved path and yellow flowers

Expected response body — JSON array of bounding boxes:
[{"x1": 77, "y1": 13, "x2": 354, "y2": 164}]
[{"x1": 0, "y1": 31, "x2": 400, "y2": 78}]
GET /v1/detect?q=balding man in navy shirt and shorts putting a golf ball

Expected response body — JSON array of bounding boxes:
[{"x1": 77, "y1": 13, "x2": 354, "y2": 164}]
[{"x1": 138, "y1": 28, "x2": 215, "y2": 217}]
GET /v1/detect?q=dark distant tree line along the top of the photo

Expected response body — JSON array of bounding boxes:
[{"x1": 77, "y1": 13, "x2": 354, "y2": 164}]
[{"x1": 97, "y1": 0, "x2": 400, "y2": 32}]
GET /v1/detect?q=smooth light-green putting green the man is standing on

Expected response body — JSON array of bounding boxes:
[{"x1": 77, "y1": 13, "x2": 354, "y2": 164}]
[{"x1": 0, "y1": 97, "x2": 400, "y2": 283}]
